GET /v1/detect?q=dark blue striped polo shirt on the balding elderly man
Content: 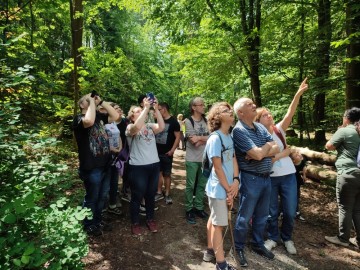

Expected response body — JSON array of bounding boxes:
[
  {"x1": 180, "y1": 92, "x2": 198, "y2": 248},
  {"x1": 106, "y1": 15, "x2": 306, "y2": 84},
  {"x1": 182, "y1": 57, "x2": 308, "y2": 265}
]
[{"x1": 231, "y1": 120, "x2": 273, "y2": 173}]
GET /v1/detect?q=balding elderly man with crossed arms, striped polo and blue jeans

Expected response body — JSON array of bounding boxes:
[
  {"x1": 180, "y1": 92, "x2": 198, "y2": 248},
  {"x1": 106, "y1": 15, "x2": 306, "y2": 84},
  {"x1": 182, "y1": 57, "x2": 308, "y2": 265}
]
[{"x1": 232, "y1": 98, "x2": 279, "y2": 267}]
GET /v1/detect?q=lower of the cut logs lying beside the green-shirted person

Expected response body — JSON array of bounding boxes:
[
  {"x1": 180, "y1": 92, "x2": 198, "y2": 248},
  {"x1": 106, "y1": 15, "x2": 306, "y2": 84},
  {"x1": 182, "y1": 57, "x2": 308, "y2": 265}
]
[{"x1": 304, "y1": 164, "x2": 337, "y2": 187}]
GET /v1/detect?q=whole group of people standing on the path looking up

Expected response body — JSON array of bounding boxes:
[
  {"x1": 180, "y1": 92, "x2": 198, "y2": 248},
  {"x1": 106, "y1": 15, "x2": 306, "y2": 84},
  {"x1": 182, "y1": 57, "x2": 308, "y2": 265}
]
[{"x1": 74, "y1": 79, "x2": 360, "y2": 270}]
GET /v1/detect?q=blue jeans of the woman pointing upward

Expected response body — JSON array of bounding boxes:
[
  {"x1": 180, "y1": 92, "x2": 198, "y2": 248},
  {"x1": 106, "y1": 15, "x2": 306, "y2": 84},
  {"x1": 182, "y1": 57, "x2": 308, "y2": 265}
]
[{"x1": 267, "y1": 174, "x2": 298, "y2": 242}]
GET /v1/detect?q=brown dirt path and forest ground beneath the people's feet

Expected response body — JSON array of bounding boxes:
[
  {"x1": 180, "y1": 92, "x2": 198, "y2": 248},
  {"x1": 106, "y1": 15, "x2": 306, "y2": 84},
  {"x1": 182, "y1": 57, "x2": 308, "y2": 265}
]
[{"x1": 83, "y1": 150, "x2": 360, "y2": 270}]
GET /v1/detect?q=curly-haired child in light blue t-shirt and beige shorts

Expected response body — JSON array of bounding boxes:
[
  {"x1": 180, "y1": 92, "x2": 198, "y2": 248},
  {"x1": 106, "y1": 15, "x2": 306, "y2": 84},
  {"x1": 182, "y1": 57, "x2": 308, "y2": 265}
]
[{"x1": 203, "y1": 102, "x2": 240, "y2": 270}]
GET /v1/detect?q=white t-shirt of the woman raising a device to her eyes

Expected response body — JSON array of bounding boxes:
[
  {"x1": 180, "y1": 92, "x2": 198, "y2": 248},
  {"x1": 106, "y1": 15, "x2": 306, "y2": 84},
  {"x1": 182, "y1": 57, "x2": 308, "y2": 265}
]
[{"x1": 126, "y1": 123, "x2": 160, "y2": 165}]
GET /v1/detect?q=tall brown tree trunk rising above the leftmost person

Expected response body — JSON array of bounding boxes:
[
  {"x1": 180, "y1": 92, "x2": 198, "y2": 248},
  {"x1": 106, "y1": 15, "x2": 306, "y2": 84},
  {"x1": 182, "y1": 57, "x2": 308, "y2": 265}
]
[{"x1": 69, "y1": 0, "x2": 84, "y2": 116}]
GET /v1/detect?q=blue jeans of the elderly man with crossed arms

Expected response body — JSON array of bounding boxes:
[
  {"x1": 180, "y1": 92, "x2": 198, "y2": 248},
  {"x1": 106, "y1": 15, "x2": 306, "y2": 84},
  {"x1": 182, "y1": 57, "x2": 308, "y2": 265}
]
[{"x1": 234, "y1": 172, "x2": 271, "y2": 250}]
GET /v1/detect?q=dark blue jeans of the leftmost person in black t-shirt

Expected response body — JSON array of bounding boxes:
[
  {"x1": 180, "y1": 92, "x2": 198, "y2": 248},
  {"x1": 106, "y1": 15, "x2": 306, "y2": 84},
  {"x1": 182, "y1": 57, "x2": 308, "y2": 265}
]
[{"x1": 79, "y1": 167, "x2": 110, "y2": 228}]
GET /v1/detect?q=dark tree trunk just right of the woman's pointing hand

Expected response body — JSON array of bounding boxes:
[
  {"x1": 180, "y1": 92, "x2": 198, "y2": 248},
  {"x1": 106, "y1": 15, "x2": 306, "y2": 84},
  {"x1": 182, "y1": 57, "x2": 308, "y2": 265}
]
[{"x1": 314, "y1": 0, "x2": 331, "y2": 143}]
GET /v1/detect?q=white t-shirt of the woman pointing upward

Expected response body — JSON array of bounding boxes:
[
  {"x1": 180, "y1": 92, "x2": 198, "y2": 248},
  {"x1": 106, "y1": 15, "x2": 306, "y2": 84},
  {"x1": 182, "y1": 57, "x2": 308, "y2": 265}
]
[{"x1": 270, "y1": 124, "x2": 296, "y2": 177}]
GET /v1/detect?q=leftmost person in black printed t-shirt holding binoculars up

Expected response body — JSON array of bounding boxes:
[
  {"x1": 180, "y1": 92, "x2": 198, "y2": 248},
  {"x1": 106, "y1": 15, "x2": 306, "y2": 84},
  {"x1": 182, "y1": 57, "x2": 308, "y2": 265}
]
[{"x1": 73, "y1": 91, "x2": 119, "y2": 236}]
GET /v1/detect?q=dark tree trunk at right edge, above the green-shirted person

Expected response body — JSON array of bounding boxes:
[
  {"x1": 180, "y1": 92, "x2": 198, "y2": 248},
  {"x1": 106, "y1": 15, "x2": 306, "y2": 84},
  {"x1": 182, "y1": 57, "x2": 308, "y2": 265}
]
[{"x1": 344, "y1": 0, "x2": 360, "y2": 109}]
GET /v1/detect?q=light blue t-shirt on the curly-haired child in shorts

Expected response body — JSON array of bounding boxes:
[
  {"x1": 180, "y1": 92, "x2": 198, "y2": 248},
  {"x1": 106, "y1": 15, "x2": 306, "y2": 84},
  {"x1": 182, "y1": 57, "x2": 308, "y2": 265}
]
[{"x1": 205, "y1": 130, "x2": 234, "y2": 200}]
